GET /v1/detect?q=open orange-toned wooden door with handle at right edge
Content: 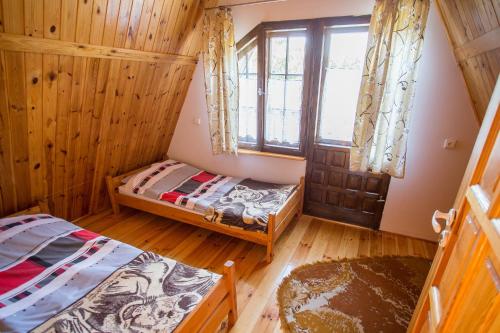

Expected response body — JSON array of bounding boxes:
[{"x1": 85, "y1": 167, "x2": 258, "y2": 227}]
[{"x1": 409, "y1": 78, "x2": 500, "y2": 332}]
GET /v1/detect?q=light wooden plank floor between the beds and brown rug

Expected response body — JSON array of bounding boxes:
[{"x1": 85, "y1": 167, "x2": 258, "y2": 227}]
[{"x1": 77, "y1": 209, "x2": 436, "y2": 333}]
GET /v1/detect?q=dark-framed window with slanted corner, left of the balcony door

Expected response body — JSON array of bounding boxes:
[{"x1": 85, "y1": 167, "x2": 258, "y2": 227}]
[{"x1": 238, "y1": 24, "x2": 309, "y2": 155}]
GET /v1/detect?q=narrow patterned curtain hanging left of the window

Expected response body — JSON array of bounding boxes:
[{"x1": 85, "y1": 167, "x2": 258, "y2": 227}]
[{"x1": 203, "y1": 8, "x2": 238, "y2": 154}]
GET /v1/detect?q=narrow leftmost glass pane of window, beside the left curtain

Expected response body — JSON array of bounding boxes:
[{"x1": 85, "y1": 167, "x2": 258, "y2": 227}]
[{"x1": 238, "y1": 46, "x2": 257, "y2": 144}]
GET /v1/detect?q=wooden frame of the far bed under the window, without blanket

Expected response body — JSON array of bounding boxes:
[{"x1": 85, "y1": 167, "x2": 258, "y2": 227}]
[{"x1": 106, "y1": 166, "x2": 304, "y2": 263}]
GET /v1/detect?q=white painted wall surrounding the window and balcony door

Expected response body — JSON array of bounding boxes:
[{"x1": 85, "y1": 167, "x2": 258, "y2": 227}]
[{"x1": 169, "y1": 0, "x2": 478, "y2": 239}]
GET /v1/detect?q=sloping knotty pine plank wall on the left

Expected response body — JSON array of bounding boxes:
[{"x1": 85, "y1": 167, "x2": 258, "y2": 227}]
[{"x1": 0, "y1": 0, "x2": 213, "y2": 219}]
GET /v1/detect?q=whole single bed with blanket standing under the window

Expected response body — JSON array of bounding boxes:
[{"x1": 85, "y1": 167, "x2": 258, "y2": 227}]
[{"x1": 106, "y1": 160, "x2": 304, "y2": 263}]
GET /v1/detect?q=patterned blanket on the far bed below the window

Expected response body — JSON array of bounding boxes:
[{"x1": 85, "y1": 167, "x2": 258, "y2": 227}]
[{"x1": 120, "y1": 160, "x2": 295, "y2": 232}]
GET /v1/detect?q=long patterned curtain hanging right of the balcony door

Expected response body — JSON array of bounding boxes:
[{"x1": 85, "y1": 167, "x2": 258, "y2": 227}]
[{"x1": 350, "y1": 0, "x2": 430, "y2": 178}]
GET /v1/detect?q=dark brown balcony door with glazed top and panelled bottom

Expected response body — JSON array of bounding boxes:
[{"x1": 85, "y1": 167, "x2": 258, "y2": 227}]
[{"x1": 304, "y1": 18, "x2": 390, "y2": 229}]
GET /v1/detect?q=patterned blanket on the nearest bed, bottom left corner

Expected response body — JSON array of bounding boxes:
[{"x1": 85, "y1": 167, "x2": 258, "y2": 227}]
[{"x1": 0, "y1": 214, "x2": 220, "y2": 332}]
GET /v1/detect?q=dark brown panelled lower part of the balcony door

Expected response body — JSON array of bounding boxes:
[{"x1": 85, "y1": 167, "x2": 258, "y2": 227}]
[{"x1": 305, "y1": 144, "x2": 390, "y2": 229}]
